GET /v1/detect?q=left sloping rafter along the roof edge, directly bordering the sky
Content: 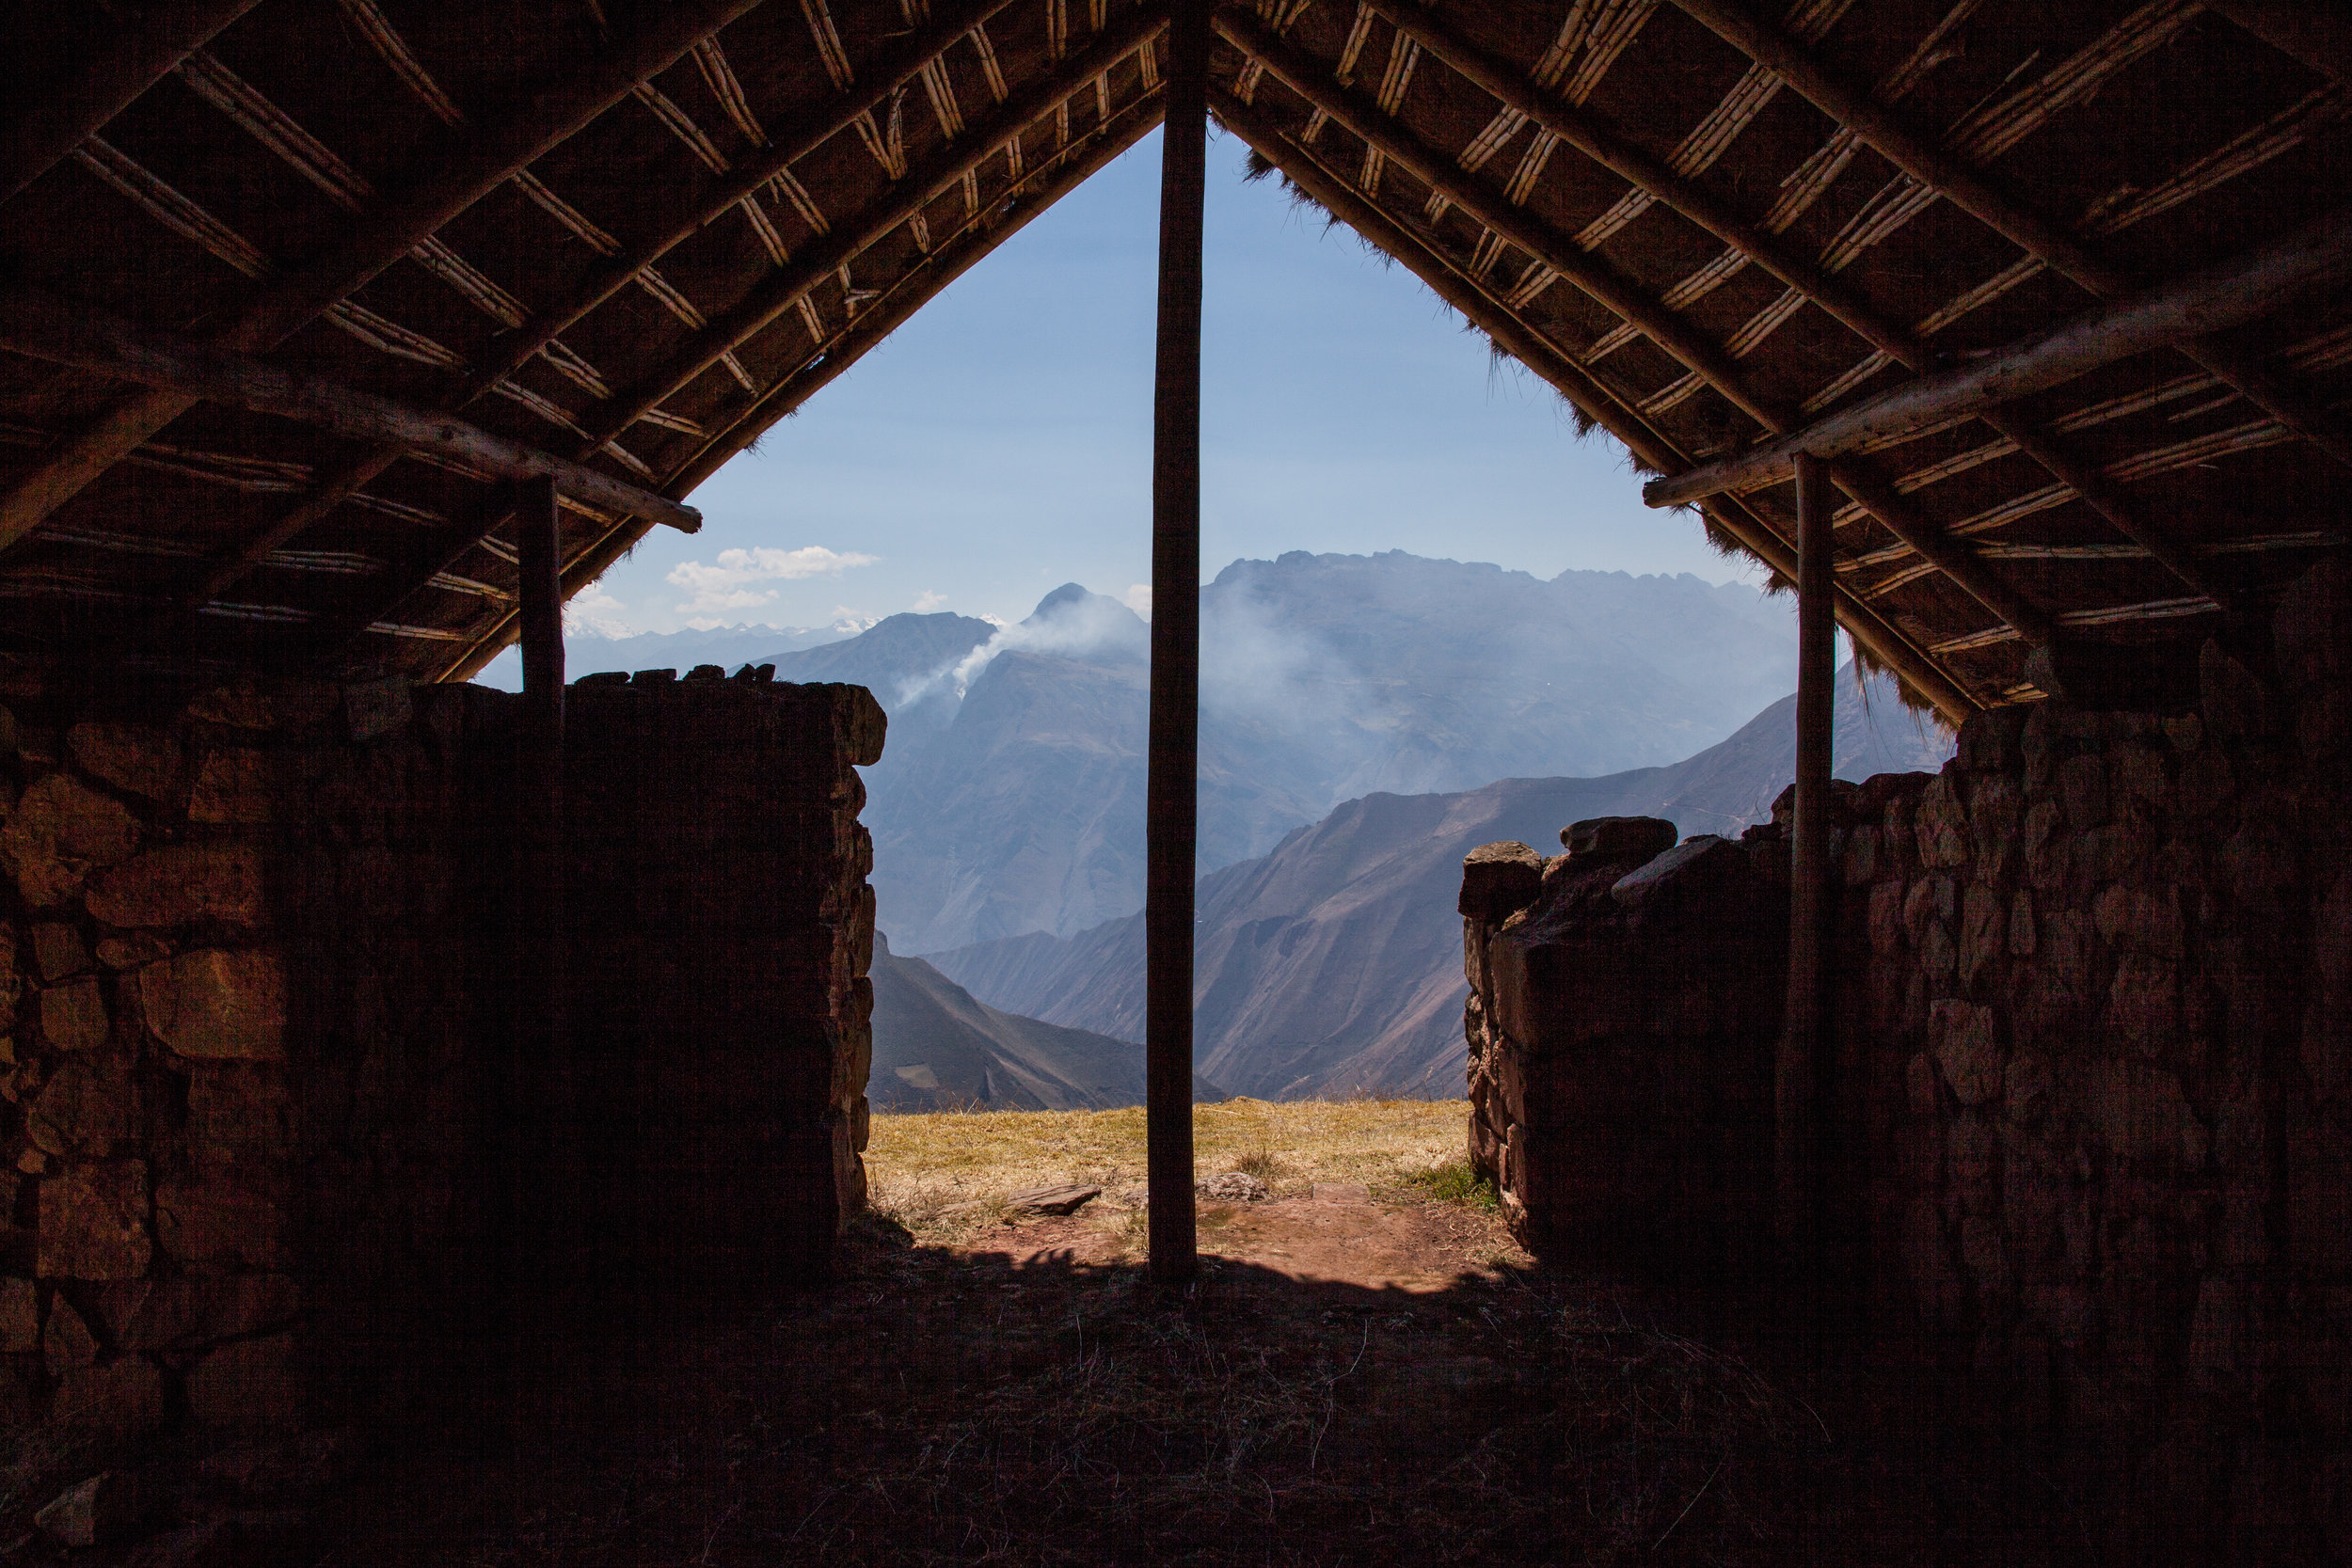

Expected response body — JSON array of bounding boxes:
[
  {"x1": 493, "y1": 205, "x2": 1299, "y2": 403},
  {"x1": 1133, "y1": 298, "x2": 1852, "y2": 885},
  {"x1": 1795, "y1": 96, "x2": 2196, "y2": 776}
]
[{"x1": 436, "y1": 96, "x2": 1160, "y2": 682}]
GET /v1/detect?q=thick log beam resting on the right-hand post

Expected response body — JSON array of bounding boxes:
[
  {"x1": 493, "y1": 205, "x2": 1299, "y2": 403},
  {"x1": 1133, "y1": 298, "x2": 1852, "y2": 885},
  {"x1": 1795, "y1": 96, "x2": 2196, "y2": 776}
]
[{"x1": 1642, "y1": 212, "x2": 2352, "y2": 505}]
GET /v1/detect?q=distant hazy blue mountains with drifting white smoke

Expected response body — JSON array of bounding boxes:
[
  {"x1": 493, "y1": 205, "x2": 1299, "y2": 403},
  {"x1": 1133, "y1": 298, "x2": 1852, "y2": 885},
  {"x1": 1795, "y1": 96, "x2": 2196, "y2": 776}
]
[{"x1": 762, "y1": 552, "x2": 1795, "y2": 952}]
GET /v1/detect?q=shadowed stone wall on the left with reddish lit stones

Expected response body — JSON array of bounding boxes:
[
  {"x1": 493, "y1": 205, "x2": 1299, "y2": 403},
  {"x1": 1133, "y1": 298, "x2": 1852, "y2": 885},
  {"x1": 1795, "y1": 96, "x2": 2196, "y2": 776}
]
[{"x1": 0, "y1": 670, "x2": 882, "y2": 1446}]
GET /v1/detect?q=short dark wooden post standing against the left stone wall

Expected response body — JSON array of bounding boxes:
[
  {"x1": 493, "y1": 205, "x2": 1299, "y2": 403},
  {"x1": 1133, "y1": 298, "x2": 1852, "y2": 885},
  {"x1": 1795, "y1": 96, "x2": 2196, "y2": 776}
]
[{"x1": 513, "y1": 480, "x2": 579, "y2": 1359}]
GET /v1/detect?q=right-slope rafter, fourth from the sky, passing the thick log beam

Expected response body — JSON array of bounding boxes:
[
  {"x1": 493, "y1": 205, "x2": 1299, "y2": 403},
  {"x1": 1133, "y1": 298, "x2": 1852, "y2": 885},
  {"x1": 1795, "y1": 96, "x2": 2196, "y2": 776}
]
[{"x1": 1675, "y1": 0, "x2": 2352, "y2": 466}]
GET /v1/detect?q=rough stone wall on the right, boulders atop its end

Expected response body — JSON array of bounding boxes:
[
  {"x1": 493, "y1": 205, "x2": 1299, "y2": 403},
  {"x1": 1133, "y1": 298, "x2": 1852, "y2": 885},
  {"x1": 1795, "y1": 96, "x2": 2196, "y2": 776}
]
[{"x1": 1463, "y1": 564, "x2": 2352, "y2": 1561}]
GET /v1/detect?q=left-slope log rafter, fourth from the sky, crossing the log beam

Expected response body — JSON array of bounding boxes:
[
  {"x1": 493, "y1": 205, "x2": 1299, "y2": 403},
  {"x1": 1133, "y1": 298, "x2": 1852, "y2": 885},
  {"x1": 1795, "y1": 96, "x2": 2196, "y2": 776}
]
[{"x1": 0, "y1": 0, "x2": 760, "y2": 550}]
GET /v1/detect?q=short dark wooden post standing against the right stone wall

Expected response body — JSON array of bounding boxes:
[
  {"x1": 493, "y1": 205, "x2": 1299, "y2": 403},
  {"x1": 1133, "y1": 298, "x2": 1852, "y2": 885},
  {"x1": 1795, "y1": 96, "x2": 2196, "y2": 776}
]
[{"x1": 1773, "y1": 453, "x2": 1837, "y2": 1307}]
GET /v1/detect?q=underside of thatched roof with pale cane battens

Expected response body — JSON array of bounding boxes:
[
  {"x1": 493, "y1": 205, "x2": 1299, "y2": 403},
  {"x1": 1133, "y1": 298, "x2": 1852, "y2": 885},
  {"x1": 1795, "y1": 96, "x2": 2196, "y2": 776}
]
[{"x1": 0, "y1": 0, "x2": 2352, "y2": 715}]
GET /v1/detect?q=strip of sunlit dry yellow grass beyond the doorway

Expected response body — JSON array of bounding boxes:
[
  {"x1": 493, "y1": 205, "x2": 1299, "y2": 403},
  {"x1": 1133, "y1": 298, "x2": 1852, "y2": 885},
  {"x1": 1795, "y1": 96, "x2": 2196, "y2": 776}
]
[{"x1": 866, "y1": 1101, "x2": 1470, "y2": 1239}]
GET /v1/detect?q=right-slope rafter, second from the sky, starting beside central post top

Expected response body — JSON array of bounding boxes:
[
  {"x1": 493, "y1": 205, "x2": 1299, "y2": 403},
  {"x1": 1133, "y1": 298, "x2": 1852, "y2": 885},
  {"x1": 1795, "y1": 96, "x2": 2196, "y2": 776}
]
[{"x1": 1216, "y1": 7, "x2": 2051, "y2": 644}]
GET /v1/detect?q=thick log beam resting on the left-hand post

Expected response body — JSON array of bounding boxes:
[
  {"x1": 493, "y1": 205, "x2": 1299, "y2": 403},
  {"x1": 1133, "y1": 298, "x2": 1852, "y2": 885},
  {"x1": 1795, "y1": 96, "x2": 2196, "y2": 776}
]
[{"x1": 0, "y1": 284, "x2": 704, "y2": 533}]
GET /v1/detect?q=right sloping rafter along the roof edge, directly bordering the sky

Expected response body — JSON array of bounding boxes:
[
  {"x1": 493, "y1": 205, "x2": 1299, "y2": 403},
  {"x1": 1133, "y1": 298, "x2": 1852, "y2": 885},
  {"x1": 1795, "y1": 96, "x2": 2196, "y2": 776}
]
[{"x1": 1209, "y1": 87, "x2": 1997, "y2": 724}]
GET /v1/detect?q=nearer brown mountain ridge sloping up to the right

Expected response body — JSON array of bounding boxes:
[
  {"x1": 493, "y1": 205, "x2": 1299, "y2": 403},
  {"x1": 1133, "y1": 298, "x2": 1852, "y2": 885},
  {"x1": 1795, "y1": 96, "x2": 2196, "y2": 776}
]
[{"x1": 931, "y1": 665, "x2": 1950, "y2": 1101}]
